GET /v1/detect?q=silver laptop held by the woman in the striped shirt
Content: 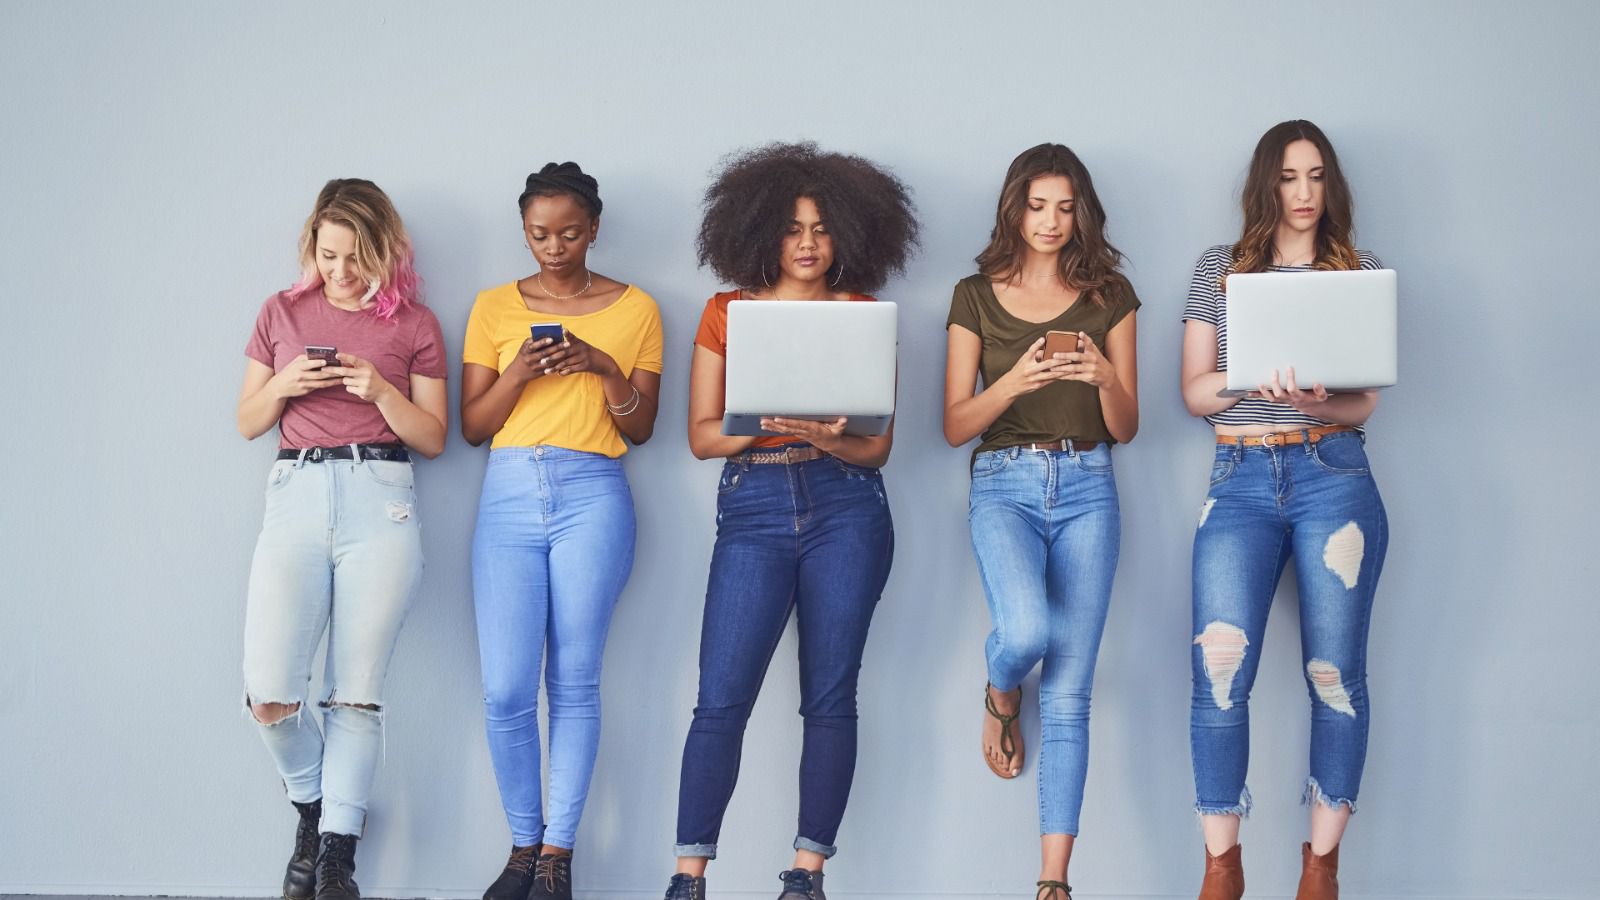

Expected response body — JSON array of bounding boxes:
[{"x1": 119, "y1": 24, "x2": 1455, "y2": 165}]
[{"x1": 1218, "y1": 269, "x2": 1398, "y2": 397}]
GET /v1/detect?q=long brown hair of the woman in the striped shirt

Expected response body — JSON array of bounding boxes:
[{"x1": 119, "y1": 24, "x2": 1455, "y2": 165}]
[{"x1": 1224, "y1": 119, "x2": 1360, "y2": 277}]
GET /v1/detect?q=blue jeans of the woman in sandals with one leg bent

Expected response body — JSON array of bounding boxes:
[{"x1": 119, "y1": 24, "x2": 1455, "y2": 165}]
[{"x1": 968, "y1": 444, "x2": 1122, "y2": 834}]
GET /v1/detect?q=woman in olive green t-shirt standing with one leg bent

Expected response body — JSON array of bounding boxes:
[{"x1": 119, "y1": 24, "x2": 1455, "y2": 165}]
[{"x1": 944, "y1": 144, "x2": 1139, "y2": 900}]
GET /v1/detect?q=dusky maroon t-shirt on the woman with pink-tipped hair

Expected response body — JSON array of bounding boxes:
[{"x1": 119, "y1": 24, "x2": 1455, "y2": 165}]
[{"x1": 245, "y1": 290, "x2": 445, "y2": 448}]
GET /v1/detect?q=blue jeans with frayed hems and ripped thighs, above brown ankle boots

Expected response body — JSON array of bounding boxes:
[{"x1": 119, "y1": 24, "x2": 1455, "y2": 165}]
[{"x1": 1189, "y1": 432, "x2": 1389, "y2": 815}]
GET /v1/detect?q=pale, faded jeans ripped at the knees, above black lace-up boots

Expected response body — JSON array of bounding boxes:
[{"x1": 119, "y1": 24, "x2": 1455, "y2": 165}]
[{"x1": 245, "y1": 458, "x2": 422, "y2": 834}]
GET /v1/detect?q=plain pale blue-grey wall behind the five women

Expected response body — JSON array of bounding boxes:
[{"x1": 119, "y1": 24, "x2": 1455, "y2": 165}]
[{"x1": 0, "y1": 2, "x2": 1600, "y2": 898}]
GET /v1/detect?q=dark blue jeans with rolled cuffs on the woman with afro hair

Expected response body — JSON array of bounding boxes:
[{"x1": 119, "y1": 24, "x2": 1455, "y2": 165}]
[{"x1": 675, "y1": 456, "x2": 894, "y2": 858}]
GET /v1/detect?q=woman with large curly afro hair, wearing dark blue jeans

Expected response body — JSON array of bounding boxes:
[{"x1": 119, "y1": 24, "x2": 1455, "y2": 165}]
[{"x1": 667, "y1": 144, "x2": 917, "y2": 900}]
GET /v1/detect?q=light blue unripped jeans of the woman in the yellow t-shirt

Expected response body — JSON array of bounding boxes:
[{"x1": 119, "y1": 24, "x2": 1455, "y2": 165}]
[{"x1": 472, "y1": 447, "x2": 634, "y2": 849}]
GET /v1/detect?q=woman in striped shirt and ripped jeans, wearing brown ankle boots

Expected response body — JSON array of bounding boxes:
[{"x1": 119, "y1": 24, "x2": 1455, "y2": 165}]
[{"x1": 1182, "y1": 120, "x2": 1389, "y2": 900}]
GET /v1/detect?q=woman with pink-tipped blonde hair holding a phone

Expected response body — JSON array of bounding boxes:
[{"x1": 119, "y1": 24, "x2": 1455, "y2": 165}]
[{"x1": 238, "y1": 178, "x2": 448, "y2": 900}]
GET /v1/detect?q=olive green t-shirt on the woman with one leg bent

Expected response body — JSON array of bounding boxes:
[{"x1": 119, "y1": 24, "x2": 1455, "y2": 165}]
[{"x1": 944, "y1": 275, "x2": 1139, "y2": 455}]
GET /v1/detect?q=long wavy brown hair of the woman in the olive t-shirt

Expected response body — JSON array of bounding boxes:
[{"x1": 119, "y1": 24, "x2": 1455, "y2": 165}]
[{"x1": 978, "y1": 144, "x2": 1126, "y2": 304}]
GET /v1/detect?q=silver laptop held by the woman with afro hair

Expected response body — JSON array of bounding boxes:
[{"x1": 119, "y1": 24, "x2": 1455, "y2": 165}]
[{"x1": 722, "y1": 299, "x2": 898, "y2": 436}]
